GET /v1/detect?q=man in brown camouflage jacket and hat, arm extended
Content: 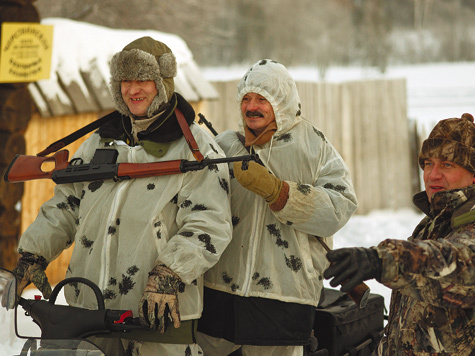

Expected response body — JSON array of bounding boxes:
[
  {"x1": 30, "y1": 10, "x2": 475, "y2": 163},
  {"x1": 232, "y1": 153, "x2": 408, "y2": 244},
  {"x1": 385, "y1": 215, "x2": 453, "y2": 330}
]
[{"x1": 325, "y1": 114, "x2": 475, "y2": 356}]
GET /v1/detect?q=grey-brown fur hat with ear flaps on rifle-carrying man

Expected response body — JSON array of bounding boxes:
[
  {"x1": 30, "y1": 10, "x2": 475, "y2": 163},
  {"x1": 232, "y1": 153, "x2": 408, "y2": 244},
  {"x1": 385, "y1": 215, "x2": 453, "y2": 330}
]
[{"x1": 110, "y1": 37, "x2": 177, "y2": 117}]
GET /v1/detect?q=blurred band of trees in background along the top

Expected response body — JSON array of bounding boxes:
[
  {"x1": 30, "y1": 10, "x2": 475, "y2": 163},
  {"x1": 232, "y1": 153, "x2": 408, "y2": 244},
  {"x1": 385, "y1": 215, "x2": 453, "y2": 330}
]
[{"x1": 35, "y1": 0, "x2": 475, "y2": 67}]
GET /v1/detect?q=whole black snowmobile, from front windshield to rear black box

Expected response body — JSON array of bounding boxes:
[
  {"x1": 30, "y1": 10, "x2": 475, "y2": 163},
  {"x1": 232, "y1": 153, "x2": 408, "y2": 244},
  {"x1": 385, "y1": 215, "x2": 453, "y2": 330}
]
[{"x1": 0, "y1": 267, "x2": 384, "y2": 356}]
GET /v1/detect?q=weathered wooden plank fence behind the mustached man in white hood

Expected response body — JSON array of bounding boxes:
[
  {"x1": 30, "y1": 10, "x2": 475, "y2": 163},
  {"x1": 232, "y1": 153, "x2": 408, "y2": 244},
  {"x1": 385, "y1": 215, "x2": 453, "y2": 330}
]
[{"x1": 203, "y1": 79, "x2": 419, "y2": 214}]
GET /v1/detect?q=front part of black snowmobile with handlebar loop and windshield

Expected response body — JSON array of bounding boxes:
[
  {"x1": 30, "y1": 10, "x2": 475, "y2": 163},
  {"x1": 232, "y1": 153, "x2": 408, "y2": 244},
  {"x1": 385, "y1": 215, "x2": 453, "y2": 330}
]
[{"x1": 0, "y1": 268, "x2": 149, "y2": 356}]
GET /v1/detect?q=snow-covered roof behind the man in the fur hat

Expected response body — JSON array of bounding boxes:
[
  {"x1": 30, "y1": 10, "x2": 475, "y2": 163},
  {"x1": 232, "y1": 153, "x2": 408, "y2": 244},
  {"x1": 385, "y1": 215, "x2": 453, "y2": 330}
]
[{"x1": 29, "y1": 18, "x2": 218, "y2": 117}]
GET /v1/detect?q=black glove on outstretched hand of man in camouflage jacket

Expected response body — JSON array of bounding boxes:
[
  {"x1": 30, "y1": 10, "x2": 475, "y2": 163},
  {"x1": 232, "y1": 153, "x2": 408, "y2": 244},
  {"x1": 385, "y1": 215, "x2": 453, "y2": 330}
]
[{"x1": 323, "y1": 247, "x2": 382, "y2": 292}]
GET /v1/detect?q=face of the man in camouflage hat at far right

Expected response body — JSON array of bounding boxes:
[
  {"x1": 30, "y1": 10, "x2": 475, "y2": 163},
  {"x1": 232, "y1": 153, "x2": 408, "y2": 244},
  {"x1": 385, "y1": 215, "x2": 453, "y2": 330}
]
[{"x1": 424, "y1": 158, "x2": 474, "y2": 201}]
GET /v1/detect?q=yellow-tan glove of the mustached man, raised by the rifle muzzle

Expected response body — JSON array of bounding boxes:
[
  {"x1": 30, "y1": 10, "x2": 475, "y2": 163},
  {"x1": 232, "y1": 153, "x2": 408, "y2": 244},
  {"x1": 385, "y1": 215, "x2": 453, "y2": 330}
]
[{"x1": 233, "y1": 161, "x2": 283, "y2": 205}]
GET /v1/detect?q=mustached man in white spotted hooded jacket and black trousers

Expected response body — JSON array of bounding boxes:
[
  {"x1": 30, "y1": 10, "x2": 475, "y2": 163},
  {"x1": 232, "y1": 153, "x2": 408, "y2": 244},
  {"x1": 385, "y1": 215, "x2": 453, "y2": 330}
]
[{"x1": 198, "y1": 60, "x2": 357, "y2": 356}]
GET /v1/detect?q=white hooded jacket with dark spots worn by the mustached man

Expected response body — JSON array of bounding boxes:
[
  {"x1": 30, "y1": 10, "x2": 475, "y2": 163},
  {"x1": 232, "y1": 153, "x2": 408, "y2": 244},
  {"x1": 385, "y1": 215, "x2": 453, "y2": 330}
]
[{"x1": 205, "y1": 60, "x2": 357, "y2": 305}]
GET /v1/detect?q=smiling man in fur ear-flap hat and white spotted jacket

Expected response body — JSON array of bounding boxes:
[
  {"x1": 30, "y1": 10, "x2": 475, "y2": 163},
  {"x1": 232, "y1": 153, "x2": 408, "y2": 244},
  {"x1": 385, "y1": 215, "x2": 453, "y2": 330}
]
[{"x1": 11, "y1": 37, "x2": 232, "y2": 355}]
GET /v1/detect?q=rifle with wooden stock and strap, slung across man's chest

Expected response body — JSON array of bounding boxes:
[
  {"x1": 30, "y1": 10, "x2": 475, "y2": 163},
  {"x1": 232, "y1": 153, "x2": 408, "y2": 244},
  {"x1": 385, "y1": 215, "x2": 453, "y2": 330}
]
[{"x1": 3, "y1": 108, "x2": 259, "y2": 184}]
